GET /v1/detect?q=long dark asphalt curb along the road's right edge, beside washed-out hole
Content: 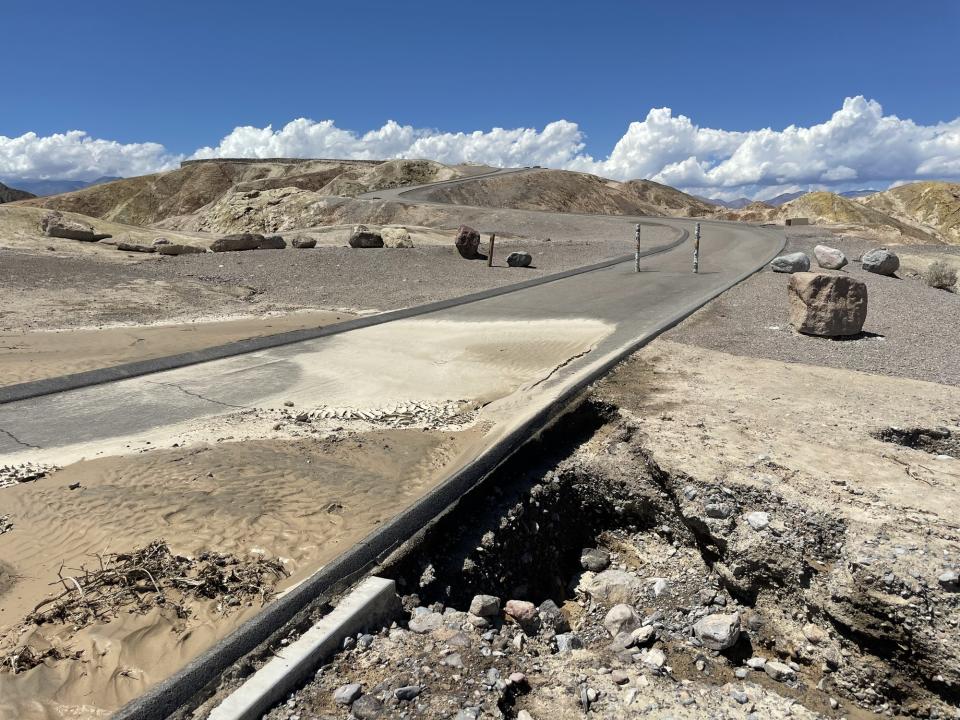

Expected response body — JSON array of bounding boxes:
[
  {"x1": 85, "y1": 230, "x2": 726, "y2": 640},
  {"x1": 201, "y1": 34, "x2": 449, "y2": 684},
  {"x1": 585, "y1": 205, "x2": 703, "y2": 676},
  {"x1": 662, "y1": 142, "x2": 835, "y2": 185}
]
[{"x1": 113, "y1": 226, "x2": 786, "y2": 720}]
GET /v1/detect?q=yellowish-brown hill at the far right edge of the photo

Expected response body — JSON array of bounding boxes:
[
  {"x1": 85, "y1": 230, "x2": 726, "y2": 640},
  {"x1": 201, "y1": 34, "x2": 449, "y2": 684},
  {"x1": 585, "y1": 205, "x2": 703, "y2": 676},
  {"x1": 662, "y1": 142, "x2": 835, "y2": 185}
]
[{"x1": 857, "y1": 182, "x2": 960, "y2": 245}]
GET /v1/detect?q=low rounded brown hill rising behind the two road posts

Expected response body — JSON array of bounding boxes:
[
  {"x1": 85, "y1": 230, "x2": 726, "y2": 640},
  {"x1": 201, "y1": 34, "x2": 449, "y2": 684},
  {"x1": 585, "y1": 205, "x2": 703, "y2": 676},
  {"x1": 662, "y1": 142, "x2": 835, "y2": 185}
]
[{"x1": 418, "y1": 170, "x2": 717, "y2": 217}]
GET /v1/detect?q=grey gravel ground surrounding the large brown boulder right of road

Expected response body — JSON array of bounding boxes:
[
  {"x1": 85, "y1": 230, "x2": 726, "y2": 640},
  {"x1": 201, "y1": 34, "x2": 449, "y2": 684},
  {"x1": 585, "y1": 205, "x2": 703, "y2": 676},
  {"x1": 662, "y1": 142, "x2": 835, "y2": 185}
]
[{"x1": 664, "y1": 229, "x2": 960, "y2": 385}]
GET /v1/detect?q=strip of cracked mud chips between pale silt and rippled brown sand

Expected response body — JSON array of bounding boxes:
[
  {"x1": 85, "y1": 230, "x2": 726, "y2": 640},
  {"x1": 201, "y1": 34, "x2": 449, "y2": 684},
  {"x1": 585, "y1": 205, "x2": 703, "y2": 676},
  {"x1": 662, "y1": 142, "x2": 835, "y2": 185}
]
[{"x1": 277, "y1": 400, "x2": 479, "y2": 429}]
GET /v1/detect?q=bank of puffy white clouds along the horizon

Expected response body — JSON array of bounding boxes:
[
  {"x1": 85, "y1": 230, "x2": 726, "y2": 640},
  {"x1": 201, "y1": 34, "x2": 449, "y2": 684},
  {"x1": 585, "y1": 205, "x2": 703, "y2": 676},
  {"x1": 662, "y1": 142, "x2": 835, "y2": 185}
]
[{"x1": 0, "y1": 96, "x2": 960, "y2": 198}]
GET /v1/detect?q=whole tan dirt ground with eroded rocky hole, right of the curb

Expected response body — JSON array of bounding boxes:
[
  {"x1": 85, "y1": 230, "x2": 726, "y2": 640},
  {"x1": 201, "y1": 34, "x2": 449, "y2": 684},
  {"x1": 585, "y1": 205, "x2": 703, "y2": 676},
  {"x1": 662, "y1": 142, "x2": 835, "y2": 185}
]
[{"x1": 248, "y1": 339, "x2": 960, "y2": 720}]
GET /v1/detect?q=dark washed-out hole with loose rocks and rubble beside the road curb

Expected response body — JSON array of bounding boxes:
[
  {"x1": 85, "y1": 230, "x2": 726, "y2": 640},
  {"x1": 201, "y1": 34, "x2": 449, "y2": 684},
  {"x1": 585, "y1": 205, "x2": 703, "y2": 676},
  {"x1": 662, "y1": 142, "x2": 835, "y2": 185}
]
[{"x1": 256, "y1": 401, "x2": 960, "y2": 720}]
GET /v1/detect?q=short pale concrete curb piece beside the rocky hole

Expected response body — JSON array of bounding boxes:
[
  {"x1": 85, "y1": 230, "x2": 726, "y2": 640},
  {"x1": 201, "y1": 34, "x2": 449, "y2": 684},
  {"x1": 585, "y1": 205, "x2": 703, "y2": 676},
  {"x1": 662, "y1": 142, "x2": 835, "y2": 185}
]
[{"x1": 209, "y1": 577, "x2": 400, "y2": 720}]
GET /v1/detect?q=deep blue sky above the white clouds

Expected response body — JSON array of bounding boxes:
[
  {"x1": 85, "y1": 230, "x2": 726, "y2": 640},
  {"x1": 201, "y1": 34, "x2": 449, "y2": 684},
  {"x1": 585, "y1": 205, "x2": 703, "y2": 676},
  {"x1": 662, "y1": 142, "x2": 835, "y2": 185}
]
[{"x1": 0, "y1": 0, "x2": 960, "y2": 197}]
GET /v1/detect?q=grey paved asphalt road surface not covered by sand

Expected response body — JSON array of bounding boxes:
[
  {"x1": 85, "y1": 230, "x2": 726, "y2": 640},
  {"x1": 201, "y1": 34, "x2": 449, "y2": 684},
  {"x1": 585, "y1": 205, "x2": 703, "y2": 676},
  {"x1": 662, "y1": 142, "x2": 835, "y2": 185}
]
[{"x1": 0, "y1": 170, "x2": 783, "y2": 456}]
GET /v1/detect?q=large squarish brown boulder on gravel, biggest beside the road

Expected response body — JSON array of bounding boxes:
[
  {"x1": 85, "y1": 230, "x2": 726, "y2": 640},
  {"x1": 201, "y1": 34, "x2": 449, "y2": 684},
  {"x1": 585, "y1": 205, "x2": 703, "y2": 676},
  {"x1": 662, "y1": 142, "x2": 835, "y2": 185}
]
[{"x1": 787, "y1": 272, "x2": 867, "y2": 337}]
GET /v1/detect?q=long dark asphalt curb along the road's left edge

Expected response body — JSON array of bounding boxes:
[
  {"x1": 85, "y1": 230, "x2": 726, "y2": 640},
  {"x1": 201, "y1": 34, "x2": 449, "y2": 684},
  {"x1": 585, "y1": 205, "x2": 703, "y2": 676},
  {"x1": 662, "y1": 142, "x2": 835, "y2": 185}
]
[{"x1": 0, "y1": 223, "x2": 690, "y2": 405}]
